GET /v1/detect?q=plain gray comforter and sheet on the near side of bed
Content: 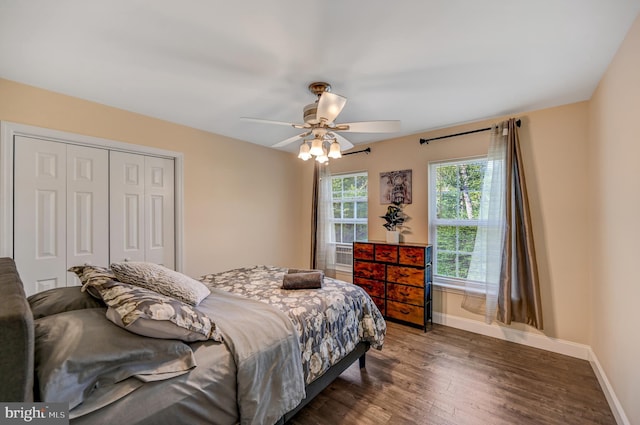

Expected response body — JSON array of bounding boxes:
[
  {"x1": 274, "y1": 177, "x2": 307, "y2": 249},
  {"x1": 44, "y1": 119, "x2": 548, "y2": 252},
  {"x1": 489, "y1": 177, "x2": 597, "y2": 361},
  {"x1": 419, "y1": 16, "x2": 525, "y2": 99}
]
[{"x1": 71, "y1": 289, "x2": 305, "y2": 425}]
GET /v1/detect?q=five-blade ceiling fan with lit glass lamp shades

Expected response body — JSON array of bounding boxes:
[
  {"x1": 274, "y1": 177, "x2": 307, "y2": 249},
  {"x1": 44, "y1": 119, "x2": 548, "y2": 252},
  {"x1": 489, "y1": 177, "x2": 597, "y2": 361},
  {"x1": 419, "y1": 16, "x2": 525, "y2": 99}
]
[{"x1": 241, "y1": 82, "x2": 400, "y2": 163}]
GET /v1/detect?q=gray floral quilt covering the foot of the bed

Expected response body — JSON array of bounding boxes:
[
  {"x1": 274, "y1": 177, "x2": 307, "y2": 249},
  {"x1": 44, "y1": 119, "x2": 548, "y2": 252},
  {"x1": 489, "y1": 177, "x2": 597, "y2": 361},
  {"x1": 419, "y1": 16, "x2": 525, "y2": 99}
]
[{"x1": 199, "y1": 266, "x2": 386, "y2": 384}]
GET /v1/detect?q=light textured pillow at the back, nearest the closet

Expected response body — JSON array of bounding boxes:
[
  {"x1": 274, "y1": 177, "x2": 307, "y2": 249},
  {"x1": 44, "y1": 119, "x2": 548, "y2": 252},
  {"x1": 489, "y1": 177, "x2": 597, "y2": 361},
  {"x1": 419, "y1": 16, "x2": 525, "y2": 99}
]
[{"x1": 111, "y1": 261, "x2": 211, "y2": 306}]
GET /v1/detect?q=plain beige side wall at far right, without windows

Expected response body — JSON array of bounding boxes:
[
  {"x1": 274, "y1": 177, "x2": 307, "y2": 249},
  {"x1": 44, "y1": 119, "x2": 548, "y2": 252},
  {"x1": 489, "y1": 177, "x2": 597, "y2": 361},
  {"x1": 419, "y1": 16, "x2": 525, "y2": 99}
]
[{"x1": 589, "y1": 13, "x2": 640, "y2": 424}]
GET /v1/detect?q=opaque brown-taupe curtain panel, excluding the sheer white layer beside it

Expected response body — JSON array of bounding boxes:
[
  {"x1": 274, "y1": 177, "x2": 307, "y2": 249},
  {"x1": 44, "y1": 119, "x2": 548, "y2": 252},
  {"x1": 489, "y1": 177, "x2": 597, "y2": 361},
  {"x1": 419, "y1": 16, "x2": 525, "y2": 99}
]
[{"x1": 497, "y1": 118, "x2": 542, "y2": 329}]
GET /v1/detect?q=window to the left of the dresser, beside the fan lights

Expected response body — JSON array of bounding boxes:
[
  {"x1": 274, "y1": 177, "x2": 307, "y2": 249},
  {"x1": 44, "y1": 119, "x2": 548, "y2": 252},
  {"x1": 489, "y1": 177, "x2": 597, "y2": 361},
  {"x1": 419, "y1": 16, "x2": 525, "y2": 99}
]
[{"x1": 331, "y1": 173, "x2": 369, "y2": 271}]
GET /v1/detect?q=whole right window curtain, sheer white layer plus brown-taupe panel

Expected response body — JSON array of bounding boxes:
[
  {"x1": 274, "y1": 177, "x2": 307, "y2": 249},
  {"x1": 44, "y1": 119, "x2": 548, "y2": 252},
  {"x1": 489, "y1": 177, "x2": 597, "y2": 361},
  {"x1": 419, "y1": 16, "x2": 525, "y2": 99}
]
[{"x1": 462, "y1": 118, "x2": 542, "y2": 329}]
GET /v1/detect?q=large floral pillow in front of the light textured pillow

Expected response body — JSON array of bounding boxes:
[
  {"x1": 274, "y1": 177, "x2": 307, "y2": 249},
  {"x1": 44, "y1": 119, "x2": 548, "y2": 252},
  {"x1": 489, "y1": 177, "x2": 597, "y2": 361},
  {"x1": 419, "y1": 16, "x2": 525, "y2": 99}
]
[{"x1": 91, "y1": 280, "x2": 222, "y2": 342}]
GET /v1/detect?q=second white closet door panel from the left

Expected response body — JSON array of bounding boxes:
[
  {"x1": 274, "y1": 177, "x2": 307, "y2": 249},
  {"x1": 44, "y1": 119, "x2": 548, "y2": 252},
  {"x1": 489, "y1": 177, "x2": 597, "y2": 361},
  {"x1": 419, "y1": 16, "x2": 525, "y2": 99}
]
[{"x1": 67, "y1": 145, "x2": 109, "y2": 285}]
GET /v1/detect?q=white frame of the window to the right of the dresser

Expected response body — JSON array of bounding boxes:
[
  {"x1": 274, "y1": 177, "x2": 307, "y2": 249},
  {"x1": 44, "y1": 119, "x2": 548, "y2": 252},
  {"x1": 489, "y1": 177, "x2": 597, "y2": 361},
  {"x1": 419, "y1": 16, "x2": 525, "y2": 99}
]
[{"x1": 428, "y1": 155, "x2": 488, "y2": 294}]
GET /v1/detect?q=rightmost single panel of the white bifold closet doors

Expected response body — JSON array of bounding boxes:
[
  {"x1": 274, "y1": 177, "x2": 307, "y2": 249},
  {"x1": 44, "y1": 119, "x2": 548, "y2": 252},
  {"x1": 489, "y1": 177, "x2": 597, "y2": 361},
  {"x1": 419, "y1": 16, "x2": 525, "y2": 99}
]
[{"x1": 145, "y1": 157, "x2": 175, "y2": 269}]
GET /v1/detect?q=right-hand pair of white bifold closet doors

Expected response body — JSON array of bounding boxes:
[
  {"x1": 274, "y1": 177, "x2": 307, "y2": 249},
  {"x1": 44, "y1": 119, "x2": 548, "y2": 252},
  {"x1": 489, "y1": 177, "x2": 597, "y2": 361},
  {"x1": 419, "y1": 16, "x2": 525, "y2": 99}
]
[{"x1": 110, "y1": 151, "x2": 175, "y2": 269}]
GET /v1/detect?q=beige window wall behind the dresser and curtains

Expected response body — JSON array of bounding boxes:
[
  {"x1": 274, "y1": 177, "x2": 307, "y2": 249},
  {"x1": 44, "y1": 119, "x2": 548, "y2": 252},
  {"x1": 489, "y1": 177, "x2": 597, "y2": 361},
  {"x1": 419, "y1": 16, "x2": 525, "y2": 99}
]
[{"x1": 330, "y1": 102, "x2": 590, "y2": 344}]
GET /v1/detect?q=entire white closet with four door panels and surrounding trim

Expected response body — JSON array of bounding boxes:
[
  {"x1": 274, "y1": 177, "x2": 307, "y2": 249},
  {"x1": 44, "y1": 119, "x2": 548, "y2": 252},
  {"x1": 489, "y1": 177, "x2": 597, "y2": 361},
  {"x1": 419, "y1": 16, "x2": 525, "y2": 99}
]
[{"x1": 5, "y1": 121, "x2": 182, "y2": 296}]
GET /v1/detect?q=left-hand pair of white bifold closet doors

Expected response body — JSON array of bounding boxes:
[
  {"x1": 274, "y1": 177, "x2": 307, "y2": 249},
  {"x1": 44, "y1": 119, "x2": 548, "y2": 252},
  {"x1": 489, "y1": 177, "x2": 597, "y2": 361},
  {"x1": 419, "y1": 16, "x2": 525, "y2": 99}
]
[{"x1": 14, "y1": 136, "x2": 109, "y2": 295}]
